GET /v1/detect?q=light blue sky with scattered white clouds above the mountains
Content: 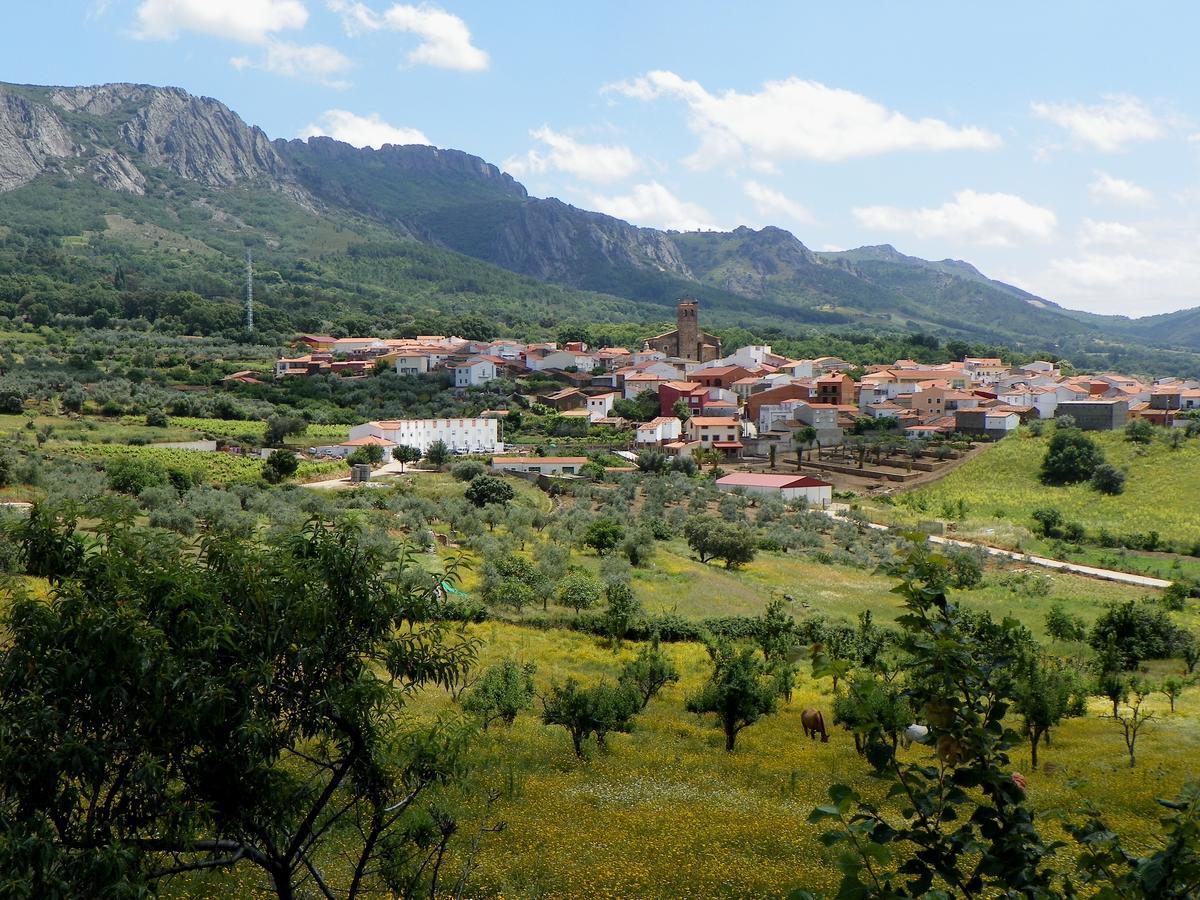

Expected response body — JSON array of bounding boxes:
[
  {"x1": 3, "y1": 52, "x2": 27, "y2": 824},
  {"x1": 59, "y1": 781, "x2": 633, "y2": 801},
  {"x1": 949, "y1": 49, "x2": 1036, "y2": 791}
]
[{"x1": 0, "y1": 0, "x2": 1200, "y2": 316}]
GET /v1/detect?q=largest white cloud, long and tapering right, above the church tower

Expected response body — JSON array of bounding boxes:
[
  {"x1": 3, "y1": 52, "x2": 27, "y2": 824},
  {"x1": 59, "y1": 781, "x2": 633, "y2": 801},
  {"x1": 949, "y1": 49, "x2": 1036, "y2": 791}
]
[{"x1": 604, "y1": 71, "x2": 1000, "y2": 170}]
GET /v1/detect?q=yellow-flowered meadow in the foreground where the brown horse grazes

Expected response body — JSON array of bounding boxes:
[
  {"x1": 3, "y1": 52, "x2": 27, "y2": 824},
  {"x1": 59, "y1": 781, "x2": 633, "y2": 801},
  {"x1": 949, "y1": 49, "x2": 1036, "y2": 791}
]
[{"x1": 175, "y1": 623, "x2": 1200, "y2": 898}]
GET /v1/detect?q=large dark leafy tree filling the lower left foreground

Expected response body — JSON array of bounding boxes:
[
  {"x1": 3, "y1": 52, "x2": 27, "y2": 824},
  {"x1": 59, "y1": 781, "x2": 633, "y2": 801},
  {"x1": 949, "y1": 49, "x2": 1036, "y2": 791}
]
[{"x1": 0, "y1": 521, "x2": 475, "y2": 900}]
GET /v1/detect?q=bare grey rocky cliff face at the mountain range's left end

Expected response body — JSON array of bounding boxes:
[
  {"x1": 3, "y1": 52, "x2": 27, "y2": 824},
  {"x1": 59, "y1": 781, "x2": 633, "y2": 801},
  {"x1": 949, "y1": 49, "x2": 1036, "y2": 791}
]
[{"x1": 0, "y1": 84, "x2": 288, "y2": 194}]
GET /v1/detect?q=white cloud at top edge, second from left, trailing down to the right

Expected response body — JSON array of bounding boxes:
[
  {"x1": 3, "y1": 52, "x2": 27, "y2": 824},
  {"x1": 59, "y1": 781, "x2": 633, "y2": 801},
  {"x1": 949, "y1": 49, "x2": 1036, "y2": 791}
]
[{"x1": 329, "y1": 0, "x2": 488, "y2": 72}]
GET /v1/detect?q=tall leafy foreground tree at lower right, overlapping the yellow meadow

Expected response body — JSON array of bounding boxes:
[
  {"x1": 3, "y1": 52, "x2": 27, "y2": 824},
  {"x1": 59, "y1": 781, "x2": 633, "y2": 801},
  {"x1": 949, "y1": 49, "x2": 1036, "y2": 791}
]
[{"x1": 810, "y1": 544, "x2": 1061, "y2": 898}]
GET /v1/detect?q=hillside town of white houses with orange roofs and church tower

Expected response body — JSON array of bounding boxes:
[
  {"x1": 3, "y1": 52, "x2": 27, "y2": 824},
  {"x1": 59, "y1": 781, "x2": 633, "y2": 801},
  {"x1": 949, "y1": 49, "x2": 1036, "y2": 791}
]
[{"x1": 275, "y1": 299, "x2": 1200, "y2": 461}]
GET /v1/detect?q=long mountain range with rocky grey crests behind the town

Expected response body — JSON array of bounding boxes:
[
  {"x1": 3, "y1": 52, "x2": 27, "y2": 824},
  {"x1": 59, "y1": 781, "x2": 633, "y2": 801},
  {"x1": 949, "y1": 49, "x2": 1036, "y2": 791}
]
[{"x1": 7, "y1": 84, "x2": 1200, "y2": 367}]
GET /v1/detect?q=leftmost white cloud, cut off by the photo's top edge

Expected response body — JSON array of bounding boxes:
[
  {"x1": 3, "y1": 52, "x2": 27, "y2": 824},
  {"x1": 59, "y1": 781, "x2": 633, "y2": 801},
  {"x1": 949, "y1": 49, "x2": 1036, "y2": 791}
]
[{"x1": 136, "y1": 0, "x2": 308, "y2": 43}]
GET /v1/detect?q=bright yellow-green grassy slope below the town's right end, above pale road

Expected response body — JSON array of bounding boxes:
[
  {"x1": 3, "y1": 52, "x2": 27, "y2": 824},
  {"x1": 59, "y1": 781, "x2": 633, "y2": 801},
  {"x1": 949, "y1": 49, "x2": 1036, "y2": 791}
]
[{"x1": 898, "y1": 430, "x2": 1200, "y2": 548}]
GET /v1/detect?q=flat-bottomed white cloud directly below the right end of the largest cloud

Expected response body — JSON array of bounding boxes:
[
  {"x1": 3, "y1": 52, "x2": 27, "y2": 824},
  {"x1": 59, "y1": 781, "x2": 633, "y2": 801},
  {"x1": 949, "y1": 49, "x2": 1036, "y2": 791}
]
[{"x1": 853, "y1": 190, "x2": 1057, "y2": 247}]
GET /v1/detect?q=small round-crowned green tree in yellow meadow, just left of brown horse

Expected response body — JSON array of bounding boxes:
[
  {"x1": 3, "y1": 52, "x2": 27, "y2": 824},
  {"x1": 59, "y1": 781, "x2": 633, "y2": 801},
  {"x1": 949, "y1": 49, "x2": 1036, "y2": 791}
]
[{"x1": 686, "y1": 641, "x2": 776, "y2": 752}]
